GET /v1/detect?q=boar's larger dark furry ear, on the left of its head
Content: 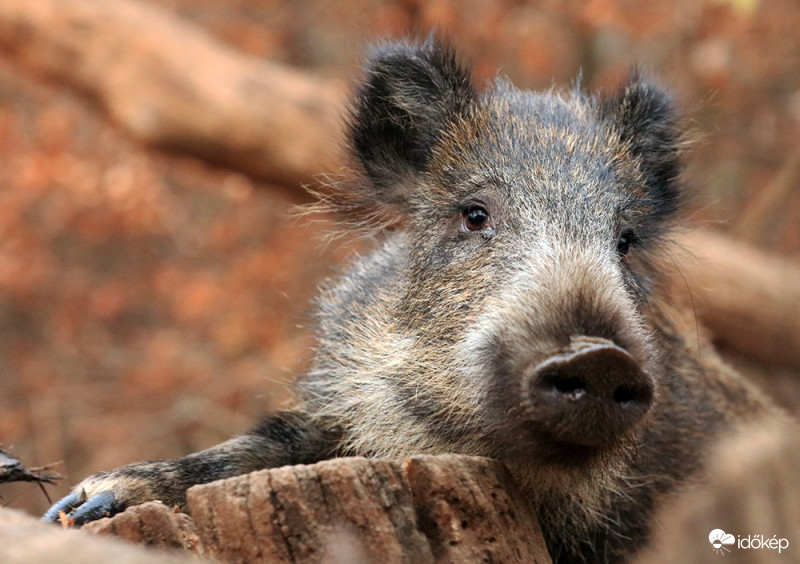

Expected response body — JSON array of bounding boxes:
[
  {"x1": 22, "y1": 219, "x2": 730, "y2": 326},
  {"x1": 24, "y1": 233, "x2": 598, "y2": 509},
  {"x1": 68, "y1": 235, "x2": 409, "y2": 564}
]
[{"x1": 348, "y1": 36, "x2": 477, "y2": 209}]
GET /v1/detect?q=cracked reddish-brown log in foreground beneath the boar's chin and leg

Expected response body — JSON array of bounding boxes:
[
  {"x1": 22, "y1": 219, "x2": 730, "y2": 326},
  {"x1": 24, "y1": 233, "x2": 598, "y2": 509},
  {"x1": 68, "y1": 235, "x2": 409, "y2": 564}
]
[{"x1": 86, "y1": 455, "x2": 550, "y2": 564}]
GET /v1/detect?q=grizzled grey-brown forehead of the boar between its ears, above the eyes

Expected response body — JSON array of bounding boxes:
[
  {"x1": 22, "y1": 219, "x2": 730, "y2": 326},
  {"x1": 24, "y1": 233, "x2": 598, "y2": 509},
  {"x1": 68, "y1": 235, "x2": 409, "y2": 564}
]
[{"x1": 428, "y1": 85, "x2": 644, "y2": 235}]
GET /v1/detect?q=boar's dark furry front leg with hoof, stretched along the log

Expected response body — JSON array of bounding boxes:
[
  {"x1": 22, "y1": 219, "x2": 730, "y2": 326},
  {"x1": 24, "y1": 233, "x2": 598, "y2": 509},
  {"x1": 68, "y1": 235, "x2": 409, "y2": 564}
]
[{"x1": 42, "y1": 412, "x2": 340, "y2": 525}]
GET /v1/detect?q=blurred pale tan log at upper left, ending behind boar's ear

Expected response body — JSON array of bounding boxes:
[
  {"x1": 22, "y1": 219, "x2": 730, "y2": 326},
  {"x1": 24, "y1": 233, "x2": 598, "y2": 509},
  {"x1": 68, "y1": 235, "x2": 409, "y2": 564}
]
[{"x1": 0, "y1": 0, "x2": 343, "y2": 188}]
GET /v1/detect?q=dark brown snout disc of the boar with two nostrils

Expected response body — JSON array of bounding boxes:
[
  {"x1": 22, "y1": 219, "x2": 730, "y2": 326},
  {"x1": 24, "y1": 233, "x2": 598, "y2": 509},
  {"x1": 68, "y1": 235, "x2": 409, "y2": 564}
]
[{"x1": 523, "y1": 337, "x2": 653, "y2": 447}]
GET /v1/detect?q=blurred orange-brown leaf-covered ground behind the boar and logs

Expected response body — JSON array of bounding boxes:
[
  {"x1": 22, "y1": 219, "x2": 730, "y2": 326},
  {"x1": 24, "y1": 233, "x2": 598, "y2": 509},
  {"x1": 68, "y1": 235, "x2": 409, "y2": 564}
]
[{"x1": 0, "y1": 0, "x2": 800, "y2": 513}]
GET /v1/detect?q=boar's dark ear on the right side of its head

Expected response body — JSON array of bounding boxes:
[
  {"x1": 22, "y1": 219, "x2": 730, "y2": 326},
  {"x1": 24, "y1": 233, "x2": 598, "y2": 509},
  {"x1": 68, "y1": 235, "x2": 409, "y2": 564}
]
[{"x1": 600, "y1": 70, "x2": 683, "y2": 215}]
